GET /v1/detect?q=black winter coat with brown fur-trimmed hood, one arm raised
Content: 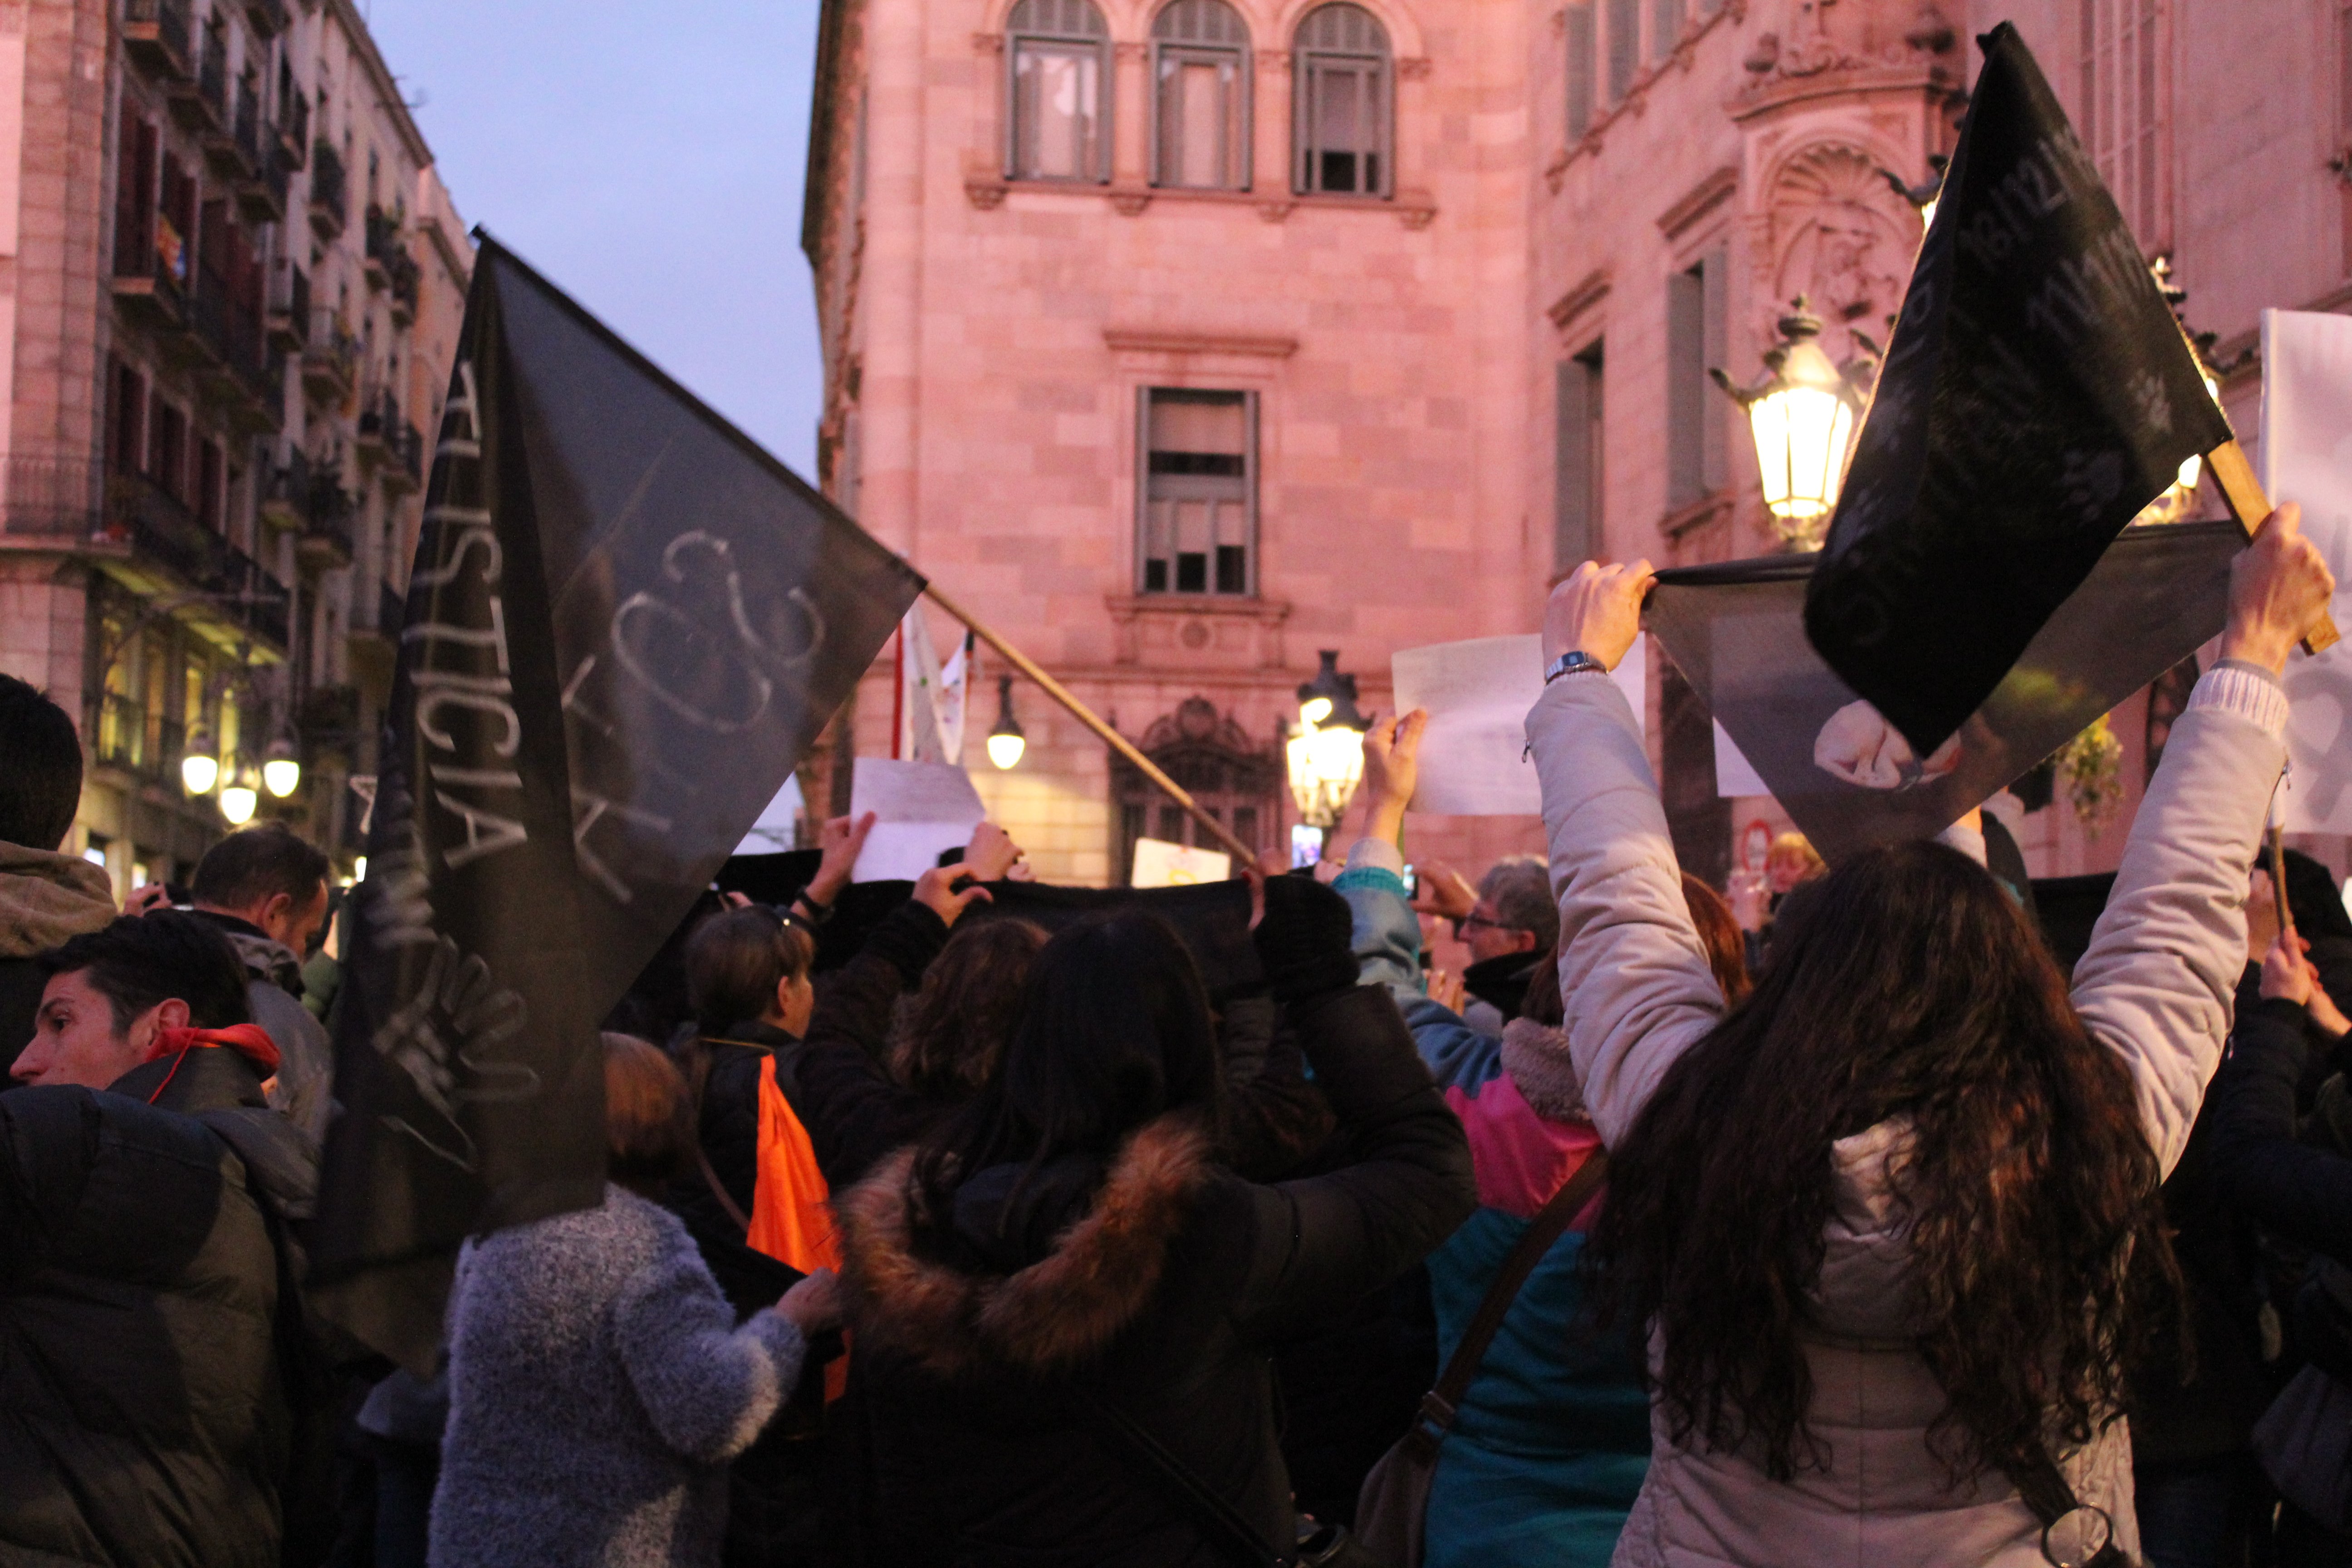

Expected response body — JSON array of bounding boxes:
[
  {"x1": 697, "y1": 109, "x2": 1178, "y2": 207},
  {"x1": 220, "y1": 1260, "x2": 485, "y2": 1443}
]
[{"x1": 838, "y1": 987, "x2": 1475, "y2": 1568}]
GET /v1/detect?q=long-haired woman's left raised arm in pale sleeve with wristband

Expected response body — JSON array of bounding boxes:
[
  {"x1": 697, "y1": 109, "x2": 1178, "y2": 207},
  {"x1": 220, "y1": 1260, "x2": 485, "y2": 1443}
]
[{"x1": 1526, "y1": 562, "x2": 1724, "y2": 1145}]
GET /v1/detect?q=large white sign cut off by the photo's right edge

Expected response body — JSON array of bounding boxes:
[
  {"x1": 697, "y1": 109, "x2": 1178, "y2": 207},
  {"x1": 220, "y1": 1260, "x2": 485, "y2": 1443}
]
[{"x1": 2263, "y1": 310, "x2": 2352, "y2": 832}]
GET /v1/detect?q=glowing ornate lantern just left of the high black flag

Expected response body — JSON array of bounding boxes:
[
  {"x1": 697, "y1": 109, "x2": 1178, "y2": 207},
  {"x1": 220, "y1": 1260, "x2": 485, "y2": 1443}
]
[{"x1": 1708, "y1": 294, "x2": 1877, "y2": 550}]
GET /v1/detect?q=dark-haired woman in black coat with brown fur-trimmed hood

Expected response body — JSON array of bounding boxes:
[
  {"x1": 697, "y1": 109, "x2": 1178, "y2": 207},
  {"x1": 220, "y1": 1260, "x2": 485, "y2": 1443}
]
[{"x1": 838, "y1": 877, "x2": 1475, "y2": 1568}]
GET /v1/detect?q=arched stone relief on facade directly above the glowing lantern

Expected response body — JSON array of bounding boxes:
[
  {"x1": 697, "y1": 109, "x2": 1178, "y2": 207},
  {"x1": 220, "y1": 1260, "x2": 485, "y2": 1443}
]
[{"x1": 1754, "y1": 141, "x2": 1919, "y2": 364}]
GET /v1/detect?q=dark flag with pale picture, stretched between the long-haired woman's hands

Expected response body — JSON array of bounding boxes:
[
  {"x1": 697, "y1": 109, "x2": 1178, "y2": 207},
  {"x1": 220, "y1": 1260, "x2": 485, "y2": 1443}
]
[{"x1": 1646, "y1": 522, "x2": 2246, "y2": 860}]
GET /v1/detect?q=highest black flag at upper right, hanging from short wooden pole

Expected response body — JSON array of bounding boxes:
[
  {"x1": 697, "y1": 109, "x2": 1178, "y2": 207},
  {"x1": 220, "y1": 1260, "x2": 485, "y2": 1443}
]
[{"x1": 1804, "y1": 21, "x2": 2230, "y2": 757}]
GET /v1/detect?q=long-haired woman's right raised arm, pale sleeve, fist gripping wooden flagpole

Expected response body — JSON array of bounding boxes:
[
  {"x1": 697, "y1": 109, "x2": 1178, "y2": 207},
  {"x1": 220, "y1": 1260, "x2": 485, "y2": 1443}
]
[{"x1": 2074, "y1": 505, "x2": 2336, "y2": 1173}]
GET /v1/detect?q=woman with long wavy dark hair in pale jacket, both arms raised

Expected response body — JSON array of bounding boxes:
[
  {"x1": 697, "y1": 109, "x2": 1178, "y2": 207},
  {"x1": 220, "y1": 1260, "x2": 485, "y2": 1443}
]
[{"x1": 1526, "y1": 508, "x2": 2333, "y2": 1568}]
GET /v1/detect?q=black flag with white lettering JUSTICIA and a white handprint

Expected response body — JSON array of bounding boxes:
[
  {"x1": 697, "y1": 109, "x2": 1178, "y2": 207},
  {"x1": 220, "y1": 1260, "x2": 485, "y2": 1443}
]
[{"x1": 313, "y1": 237, "x2": 922, "y2": 1366}]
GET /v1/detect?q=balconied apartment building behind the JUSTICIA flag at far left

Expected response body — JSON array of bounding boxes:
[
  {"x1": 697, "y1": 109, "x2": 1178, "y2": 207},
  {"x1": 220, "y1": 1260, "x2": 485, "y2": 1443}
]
[{"x1": 0, "y1": 0, "x2": 470, "y2": 891}]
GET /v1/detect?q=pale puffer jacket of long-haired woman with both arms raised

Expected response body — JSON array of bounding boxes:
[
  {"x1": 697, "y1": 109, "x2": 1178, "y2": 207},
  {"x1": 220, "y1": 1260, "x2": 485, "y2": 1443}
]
[{"x1": 1526, "y1": 663, "x2": 2286, "y2": 1568}]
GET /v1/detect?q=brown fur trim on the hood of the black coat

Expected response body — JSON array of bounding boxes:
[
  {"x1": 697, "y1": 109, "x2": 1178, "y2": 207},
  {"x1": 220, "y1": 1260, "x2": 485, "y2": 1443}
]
[{"x1": 835, "y1": 1112, "x2": 1211, "y2": 1375}]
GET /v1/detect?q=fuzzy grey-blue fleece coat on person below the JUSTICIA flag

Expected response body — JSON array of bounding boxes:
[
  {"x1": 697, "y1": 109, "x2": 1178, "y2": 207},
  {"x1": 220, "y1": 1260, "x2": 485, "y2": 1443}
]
[{"x1": 431, "y1": 1187, "x2": 804, "y2": 1568}]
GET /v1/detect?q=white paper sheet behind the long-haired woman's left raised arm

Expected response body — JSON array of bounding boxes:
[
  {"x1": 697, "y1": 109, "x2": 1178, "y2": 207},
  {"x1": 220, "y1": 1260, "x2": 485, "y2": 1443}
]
[{"x1": 1390, "y1": 632, "x2": 1649, "y2": 816}]
